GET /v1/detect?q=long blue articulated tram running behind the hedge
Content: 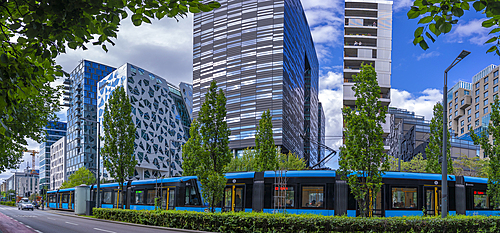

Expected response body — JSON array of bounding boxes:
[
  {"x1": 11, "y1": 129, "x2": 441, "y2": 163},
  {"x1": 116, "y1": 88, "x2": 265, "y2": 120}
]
[{"x1": 47, "y1": 170, "x2": 500, "y2": 217}]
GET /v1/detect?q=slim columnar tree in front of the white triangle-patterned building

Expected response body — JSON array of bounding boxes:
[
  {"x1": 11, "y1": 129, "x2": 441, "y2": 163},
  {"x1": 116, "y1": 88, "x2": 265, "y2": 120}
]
[{"x1": 101, "y1": 86, "x2": 137, "y2": 197}]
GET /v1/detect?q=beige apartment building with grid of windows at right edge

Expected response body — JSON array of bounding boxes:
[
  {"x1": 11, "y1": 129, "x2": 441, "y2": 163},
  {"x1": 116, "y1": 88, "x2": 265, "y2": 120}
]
[{"x1": 448, "y1": 65, "x2": 499, "y2": 158}]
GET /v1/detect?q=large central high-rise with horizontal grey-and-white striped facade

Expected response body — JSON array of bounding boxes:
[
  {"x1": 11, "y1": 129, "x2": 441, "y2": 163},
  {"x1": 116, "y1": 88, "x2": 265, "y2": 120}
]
[{"x1": 193, "y1": 0, "x2": 319, "y2": 167}]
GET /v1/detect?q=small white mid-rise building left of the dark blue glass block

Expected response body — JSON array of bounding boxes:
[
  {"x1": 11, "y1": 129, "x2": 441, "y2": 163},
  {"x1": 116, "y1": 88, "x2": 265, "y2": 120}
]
[{"x1": 49, "y1": 137, "x2": 67, "y2": 190}]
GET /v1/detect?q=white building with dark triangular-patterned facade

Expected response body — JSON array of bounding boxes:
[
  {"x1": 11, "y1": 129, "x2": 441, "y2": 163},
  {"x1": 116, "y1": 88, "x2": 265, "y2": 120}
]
[{"x1": 98, "y1": 63, "x2": 191, "y2": 179}]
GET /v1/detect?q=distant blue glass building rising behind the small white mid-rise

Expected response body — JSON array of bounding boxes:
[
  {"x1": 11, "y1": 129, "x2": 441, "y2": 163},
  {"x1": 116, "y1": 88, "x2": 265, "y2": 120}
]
[{"x1": 38, "y1": 121, "x2": 67, "y2": 190}]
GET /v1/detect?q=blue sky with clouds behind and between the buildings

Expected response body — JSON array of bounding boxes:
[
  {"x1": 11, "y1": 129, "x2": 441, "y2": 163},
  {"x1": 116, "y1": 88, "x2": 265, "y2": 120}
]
[{"x1": 0, "y1": 0, "x2": 499, "y2": 182}]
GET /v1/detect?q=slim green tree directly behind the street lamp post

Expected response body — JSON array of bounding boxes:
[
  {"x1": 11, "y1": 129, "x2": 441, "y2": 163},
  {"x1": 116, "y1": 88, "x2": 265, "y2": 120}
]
[{"x1": 425, "y1": 103, "x2": 453, "y2": 174}]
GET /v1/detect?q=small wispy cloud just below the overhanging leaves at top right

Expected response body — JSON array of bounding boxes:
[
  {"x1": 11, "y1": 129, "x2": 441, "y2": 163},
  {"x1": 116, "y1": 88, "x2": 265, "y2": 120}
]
[{"x1": 447, "y1": 19, "x2": 489, "y2": 45}]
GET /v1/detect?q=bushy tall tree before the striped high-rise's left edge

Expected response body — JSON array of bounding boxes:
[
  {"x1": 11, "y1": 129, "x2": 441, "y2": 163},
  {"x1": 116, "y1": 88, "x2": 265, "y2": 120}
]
[{"x1": 182, "y1": 80, "x2": 231, "y2": 212}]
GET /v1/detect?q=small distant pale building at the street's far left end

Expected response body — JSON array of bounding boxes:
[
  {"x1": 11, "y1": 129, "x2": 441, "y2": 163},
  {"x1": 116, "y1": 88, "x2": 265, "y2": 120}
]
[{"x1": 5, "y1": 169, "x2": 40, "y2": 197}]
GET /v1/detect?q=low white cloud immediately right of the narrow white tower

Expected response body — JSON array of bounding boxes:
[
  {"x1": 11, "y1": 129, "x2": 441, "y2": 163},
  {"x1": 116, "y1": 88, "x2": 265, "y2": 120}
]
[{"x1": 390, "y1": 89, "x2": 443, "y2": 120}]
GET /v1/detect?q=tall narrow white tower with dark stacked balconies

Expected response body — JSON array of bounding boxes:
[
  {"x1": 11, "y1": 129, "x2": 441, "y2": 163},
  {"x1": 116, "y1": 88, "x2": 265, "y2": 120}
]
[{"x1": 343, "y1": 0, "x2": 392, "y2": 150}]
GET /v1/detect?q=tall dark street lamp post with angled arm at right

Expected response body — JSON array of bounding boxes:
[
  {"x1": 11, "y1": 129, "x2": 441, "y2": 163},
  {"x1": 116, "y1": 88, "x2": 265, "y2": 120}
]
[{"x1": 441, "y1": 50, "x2": 470, "y2": 218}]
